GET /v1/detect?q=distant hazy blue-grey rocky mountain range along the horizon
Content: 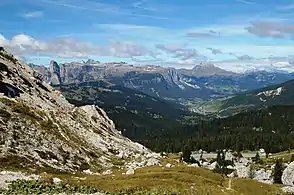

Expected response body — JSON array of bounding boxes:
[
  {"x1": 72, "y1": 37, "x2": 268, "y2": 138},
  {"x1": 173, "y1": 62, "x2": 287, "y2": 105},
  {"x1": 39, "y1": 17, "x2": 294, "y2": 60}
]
[{"x1": 30, "y1": 60, "x2": 294, "y2": 102}]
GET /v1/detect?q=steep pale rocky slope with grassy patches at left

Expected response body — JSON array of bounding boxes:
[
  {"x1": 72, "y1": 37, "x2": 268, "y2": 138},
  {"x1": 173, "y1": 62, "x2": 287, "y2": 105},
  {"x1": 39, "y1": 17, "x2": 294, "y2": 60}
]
[{"x1": 0, "y1": 48, "x2": 156, "y2": 171}]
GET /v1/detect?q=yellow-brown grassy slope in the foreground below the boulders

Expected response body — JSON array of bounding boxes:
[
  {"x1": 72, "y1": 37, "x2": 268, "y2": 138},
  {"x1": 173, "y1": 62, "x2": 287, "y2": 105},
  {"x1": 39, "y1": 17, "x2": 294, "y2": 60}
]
[{"x1": 27, "y1": 156, "x2": 282, "y2": 195}]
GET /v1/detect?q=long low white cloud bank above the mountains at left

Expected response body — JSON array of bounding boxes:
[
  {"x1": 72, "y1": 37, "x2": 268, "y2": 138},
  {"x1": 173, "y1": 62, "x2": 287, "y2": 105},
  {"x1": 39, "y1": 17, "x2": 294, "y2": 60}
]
[{"x1": 0, "y1": 34, "x2": 155, "y2": 58}]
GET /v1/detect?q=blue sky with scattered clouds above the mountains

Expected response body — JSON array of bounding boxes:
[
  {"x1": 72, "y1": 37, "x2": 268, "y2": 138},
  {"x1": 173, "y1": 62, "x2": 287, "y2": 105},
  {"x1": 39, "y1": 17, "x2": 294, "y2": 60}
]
[{"x1": 0, "y1": 0, "x2": 294, "y2": 72}]
